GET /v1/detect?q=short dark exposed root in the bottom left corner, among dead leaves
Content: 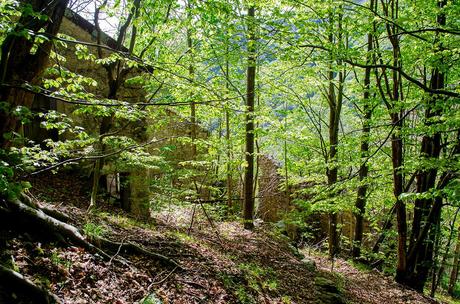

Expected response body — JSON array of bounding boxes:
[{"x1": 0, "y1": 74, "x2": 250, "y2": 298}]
[{"x1": 0, "y1": 265, "x2": 62, "y2": 304}]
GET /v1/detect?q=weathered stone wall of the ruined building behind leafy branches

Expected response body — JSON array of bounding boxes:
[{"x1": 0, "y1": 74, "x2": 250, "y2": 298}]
[{"x1": 25, "y1": 10, "x2": 207, "y2": 217}]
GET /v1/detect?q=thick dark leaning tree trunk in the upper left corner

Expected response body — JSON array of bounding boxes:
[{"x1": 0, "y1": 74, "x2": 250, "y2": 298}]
[{"x1": 0, "y1": 0, "x2": 69, "y2": 148}]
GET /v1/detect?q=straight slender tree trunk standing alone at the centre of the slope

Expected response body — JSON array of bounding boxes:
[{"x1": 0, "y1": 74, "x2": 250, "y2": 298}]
[{"x1": 243, "y1": 5, "x2": 256, "y2": 229}]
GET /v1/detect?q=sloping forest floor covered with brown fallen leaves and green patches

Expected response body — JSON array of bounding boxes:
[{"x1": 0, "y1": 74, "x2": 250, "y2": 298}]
[{"x1": 0, "y1": 175, "x2": 452, "y2": 304}]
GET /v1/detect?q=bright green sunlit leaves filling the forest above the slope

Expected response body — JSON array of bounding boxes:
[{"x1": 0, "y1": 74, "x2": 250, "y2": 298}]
[{"x1": 0, "y1": 0, "x2": 460, "y2": 296}]
